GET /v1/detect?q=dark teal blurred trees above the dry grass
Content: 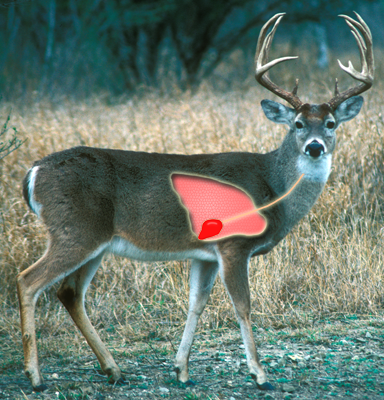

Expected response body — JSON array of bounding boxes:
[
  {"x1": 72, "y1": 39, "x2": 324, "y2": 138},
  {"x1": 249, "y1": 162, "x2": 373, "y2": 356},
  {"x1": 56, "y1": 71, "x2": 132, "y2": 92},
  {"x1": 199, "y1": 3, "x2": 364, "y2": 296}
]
[{"x1": 0, "y1": 0, "x2": 384, "y2": 100}]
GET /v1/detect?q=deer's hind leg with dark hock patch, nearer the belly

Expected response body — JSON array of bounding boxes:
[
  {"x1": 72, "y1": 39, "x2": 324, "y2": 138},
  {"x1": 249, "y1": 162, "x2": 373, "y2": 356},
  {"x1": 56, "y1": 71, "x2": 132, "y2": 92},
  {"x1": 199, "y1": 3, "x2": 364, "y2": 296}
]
[{"x1": 57, "y1": 253, "x2": 124, "y2": 383}]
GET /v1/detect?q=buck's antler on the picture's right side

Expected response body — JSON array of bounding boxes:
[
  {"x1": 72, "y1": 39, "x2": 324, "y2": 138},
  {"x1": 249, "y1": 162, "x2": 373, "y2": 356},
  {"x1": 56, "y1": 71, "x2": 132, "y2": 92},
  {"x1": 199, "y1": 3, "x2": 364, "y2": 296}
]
[{"x1": 328, "y1": 12, "x2": 374, "y2": 110}]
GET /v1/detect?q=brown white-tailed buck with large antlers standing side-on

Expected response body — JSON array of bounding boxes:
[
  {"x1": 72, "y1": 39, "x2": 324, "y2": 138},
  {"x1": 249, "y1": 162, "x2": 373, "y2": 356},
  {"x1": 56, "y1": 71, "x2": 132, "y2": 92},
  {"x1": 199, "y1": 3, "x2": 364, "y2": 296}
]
[{"x1": 17, "y1": 14, "x2": 374, "y2": 391}]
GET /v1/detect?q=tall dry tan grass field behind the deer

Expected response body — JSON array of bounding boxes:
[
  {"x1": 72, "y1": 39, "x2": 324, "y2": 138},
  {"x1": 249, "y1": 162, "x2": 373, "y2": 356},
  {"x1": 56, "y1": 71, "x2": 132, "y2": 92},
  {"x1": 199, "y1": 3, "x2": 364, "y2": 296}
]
[{"x1": 0, "y1": 54, "x2": 384, "y2": 399}]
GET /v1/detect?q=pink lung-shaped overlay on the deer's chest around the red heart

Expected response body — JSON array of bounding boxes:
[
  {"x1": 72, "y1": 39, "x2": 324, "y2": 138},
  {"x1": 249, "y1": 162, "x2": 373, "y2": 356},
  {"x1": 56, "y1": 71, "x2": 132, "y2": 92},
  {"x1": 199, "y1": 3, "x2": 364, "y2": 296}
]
[{"x1": 171, "y1": 174, "x2": 267, "y2": 240}]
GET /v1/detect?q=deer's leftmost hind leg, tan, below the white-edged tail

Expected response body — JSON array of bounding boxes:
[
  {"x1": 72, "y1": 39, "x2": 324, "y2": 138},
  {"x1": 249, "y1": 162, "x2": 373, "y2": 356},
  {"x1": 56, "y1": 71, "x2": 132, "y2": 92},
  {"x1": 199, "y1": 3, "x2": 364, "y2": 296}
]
[{"x1": 16, "y1": 240, "x2": 106, "y2": 392}]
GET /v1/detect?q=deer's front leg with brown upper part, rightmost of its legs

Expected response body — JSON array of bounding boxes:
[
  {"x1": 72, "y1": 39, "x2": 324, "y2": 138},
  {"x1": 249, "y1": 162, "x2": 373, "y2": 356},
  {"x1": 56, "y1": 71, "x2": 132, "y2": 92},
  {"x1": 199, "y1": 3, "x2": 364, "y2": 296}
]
[{"x1": 220, "y1": 252, "x2": 274, "y2": 390}]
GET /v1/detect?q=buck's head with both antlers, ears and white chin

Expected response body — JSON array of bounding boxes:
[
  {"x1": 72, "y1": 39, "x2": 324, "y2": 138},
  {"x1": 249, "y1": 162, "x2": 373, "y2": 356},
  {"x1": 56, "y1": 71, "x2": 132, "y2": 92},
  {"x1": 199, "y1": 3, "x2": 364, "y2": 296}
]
[{"x1": 255, "y1": 13, "x2": 374, "y2": 176}]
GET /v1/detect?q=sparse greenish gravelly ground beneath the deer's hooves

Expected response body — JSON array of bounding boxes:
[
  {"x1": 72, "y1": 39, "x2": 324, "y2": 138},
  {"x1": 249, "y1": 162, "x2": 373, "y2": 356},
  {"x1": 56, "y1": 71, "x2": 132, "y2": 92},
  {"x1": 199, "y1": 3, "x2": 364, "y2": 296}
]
[{"x1": 0, "y1": 317, "x2": 384, "y2": 400}]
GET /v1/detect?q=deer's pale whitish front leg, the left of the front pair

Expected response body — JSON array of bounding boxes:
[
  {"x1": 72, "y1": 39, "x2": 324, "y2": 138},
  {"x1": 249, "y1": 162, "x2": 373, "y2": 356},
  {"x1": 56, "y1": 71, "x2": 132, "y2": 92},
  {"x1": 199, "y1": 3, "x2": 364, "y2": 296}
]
[{"x1": 175, "y1": 260, "x2": 219, "y2": 385}]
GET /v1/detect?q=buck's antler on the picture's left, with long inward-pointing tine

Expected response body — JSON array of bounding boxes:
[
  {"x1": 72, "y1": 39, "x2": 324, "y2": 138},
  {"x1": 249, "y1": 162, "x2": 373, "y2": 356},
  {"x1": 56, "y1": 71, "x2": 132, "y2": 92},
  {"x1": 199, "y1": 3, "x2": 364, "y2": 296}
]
[{"x1": 255, "y1": 13, "x2": 303, "y2": 109}]
